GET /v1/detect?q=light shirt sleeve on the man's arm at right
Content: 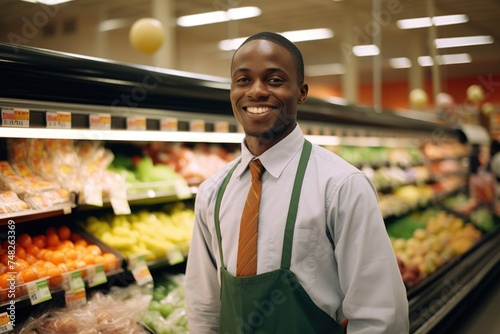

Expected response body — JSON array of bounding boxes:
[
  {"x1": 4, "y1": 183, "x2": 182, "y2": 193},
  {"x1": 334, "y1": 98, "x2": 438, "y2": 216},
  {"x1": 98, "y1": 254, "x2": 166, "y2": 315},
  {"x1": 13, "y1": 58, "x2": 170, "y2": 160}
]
[{"x1": 332, "y1": 173, "x2": 409, "y2": 334}]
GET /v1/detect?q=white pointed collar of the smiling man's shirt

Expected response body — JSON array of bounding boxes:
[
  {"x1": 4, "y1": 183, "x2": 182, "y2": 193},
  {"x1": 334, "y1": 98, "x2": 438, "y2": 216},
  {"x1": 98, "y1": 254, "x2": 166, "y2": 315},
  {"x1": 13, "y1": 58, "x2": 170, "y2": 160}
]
[{"x1": 234, "y1": 124, "x2": 304, "y2": 178}]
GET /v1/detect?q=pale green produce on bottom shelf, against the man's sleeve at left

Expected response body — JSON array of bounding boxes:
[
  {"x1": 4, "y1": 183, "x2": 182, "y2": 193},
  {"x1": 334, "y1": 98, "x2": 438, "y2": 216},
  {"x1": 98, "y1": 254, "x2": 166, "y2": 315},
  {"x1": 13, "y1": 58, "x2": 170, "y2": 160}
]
[{"x1": 141, "y1": 274, "x2": 189, "y2": 334}]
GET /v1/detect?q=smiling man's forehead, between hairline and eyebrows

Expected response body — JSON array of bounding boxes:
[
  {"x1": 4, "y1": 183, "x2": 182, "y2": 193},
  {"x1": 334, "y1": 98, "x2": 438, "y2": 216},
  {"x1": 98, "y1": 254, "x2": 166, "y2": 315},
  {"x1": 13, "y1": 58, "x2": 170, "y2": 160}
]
[{"x1": 232, "y1": 39, "x2": 294, "y2": 70}]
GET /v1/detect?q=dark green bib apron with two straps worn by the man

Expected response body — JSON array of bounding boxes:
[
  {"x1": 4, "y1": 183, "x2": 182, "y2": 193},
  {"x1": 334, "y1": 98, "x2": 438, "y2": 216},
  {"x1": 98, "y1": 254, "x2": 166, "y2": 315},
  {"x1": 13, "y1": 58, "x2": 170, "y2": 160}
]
[{"x1": 215, "y1": 140, "x2": 341, "y2": 334}]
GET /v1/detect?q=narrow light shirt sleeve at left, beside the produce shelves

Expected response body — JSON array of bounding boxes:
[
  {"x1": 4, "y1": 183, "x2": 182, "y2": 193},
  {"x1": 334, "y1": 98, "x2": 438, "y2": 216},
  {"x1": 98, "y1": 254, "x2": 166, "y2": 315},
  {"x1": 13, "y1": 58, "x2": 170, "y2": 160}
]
[{"x1": 185, "y1": 188, "x2": 220, "y2": 334}]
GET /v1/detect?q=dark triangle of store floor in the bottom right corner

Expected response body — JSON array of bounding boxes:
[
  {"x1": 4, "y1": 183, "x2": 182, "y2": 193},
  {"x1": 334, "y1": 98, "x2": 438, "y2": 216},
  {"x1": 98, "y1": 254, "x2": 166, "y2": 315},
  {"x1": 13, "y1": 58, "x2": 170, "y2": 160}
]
[{"x1": 452, "y1": 280, "x2": 500, "y2": 334}]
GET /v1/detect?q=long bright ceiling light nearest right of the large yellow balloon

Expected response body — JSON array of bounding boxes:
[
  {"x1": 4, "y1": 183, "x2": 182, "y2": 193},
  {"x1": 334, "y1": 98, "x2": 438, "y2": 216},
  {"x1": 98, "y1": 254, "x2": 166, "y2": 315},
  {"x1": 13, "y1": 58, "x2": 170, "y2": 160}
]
[{"x1": 177, "y1": 6, "x2": 262, "y2": 27}]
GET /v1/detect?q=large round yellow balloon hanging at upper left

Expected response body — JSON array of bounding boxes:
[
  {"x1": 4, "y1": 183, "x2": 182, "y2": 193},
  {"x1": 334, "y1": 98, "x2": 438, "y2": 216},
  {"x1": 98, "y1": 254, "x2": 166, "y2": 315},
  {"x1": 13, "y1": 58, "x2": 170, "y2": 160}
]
[{"x1": 129, "y1": 18, "x2": 164, "y2": 54}]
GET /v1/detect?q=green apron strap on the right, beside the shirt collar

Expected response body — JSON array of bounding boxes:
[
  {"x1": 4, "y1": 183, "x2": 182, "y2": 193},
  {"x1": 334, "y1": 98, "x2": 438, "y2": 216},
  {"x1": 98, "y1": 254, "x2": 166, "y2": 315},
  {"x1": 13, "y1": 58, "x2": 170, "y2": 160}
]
[{"x1": 281, "y1": 139, "x2": 312, "y2": 269}]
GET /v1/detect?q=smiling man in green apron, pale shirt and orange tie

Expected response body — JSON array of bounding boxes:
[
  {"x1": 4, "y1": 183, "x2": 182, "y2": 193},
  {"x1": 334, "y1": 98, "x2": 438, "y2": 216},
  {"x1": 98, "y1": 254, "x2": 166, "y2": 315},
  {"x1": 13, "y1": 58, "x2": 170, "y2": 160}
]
[{"x1": 186, "y1": 32, "x2": 409, "y2": 334}]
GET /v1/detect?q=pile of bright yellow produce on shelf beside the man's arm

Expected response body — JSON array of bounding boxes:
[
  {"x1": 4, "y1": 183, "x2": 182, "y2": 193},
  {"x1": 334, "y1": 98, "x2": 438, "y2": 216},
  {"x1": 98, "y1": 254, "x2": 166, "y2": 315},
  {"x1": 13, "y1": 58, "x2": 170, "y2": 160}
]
[{"x1": 82, "y1": 202, "x2": 194, "y2": 260}]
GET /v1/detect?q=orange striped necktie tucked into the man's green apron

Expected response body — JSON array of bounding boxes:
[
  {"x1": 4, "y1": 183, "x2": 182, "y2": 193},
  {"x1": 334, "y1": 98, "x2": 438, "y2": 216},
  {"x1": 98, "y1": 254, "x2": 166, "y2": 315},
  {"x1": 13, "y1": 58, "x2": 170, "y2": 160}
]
[{"x1": 236, "y1": 160, "x2": 264, "y2": 276}]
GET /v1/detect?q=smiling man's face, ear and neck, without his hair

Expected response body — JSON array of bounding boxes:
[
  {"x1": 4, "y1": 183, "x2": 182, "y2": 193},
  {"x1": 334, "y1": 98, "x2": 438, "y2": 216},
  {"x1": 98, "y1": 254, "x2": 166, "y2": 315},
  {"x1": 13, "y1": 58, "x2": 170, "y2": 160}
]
[{"x1": 231, "y1": 39, "x2": 309, "y2": 156}]
